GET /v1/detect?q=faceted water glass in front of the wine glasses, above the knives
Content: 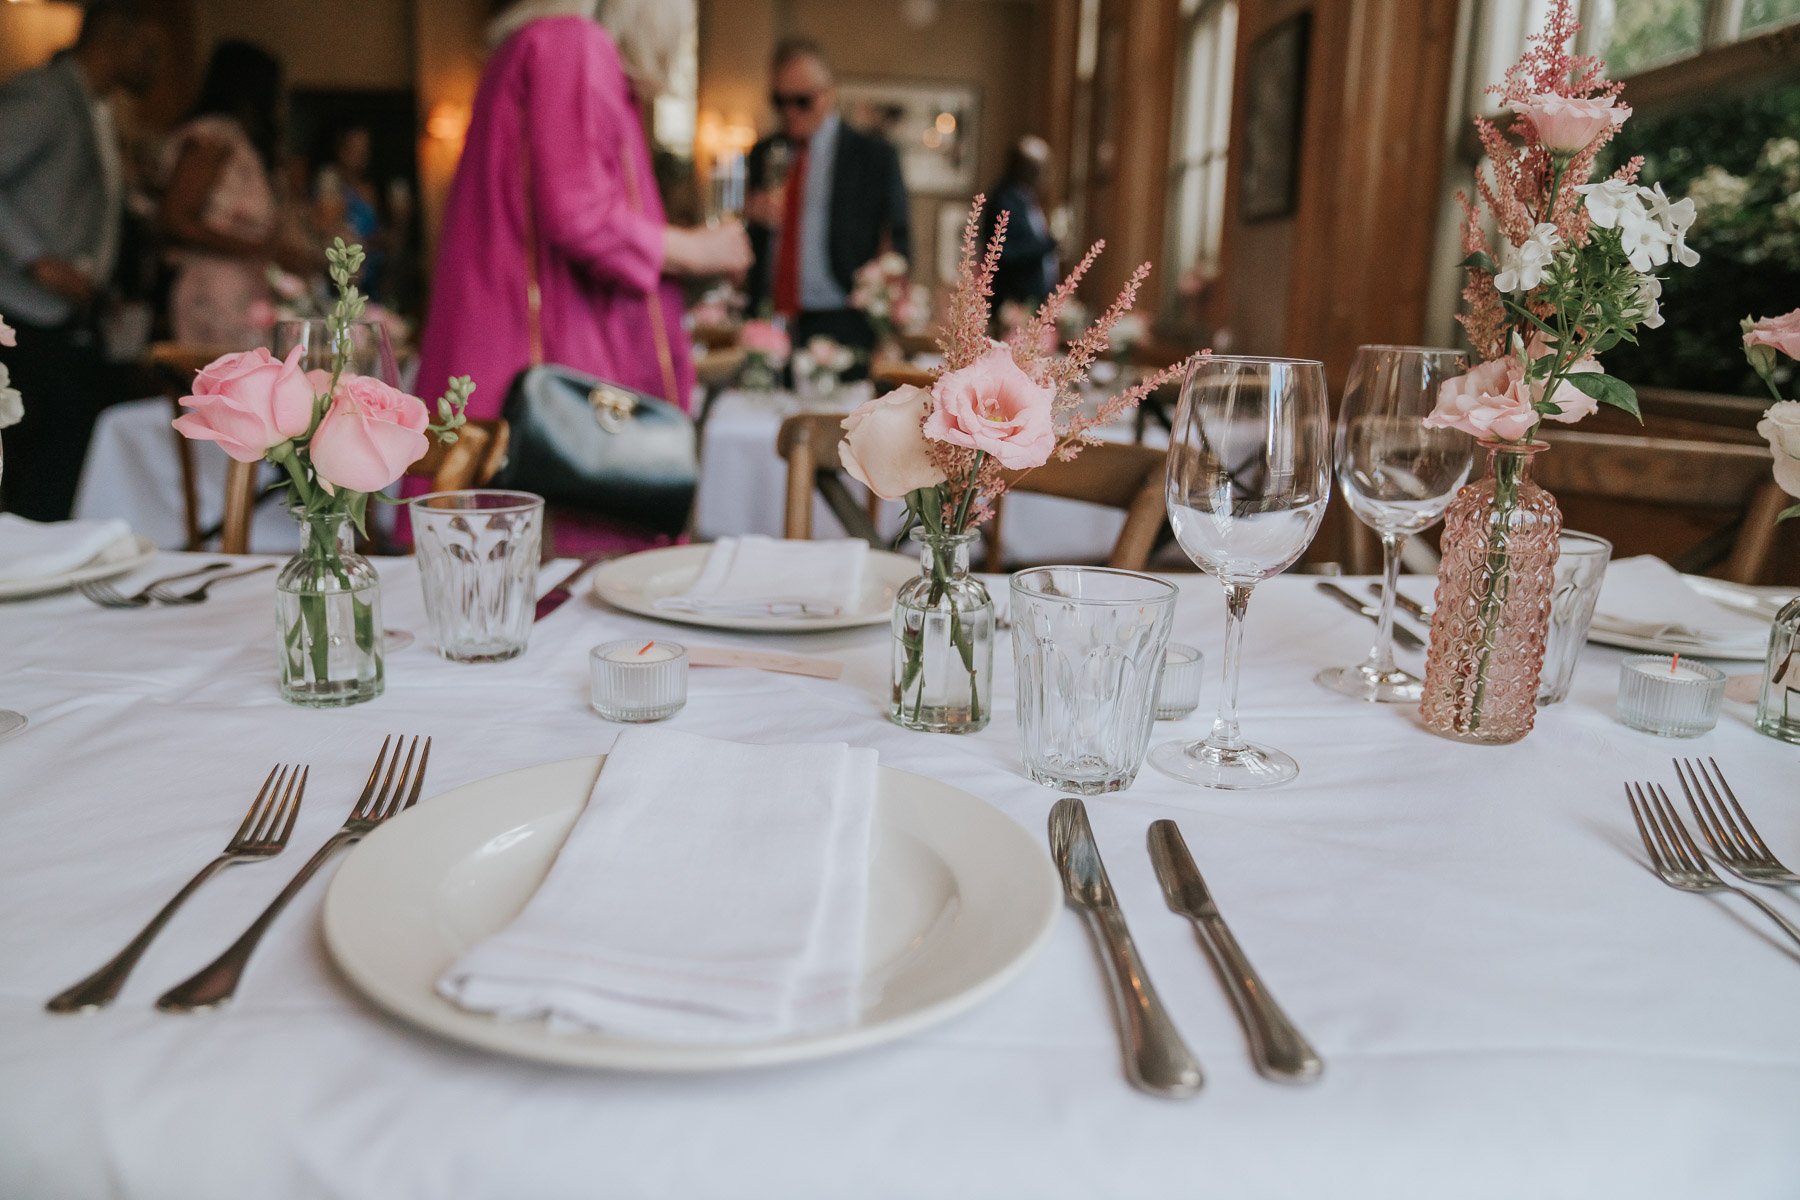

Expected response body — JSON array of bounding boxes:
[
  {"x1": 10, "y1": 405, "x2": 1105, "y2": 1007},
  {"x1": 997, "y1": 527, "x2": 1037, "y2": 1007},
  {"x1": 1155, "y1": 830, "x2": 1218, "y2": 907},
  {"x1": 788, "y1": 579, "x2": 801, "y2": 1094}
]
[{"x1": 1012, "y1": 567, "x2": 1177, "y2": 795}]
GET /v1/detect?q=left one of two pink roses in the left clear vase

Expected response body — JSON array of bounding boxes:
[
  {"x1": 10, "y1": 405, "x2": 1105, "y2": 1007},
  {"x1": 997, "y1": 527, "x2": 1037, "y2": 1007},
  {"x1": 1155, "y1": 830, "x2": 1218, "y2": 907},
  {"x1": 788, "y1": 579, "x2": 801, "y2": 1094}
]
[{"x1": 175, "y1": 345, "x2": 313, "y2": 462}]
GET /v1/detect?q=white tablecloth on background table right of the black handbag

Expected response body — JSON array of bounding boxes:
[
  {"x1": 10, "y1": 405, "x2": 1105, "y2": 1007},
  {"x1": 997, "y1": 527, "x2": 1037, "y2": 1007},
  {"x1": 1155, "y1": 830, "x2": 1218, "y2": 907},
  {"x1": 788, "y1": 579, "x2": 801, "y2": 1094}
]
[{"x1": 695, "y1": 392, "x2": 1152, "y2": 563}]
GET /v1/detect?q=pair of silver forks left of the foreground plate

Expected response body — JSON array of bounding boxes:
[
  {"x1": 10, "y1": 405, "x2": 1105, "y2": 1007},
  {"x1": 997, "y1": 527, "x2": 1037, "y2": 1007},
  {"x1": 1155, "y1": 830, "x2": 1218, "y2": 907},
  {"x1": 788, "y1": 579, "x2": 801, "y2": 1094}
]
[{"x1": 45, "y1": 736, "x2": 432, "y2": 1013}]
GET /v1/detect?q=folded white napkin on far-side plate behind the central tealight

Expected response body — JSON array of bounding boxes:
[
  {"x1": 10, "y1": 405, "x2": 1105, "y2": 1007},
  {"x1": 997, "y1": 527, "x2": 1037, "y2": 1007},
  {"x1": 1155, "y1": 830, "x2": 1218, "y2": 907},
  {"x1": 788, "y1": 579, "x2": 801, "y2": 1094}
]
[{"x1": 655, "y1": 536, "x2": 869, "y2": 617}]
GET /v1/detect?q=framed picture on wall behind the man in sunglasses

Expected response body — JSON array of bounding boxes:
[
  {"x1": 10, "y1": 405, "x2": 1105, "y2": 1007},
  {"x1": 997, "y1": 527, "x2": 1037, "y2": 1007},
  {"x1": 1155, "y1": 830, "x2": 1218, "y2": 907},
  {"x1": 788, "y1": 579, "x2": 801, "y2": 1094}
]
[{"x1": 837, "y1": 79, "x2": 981, "y2": 196}]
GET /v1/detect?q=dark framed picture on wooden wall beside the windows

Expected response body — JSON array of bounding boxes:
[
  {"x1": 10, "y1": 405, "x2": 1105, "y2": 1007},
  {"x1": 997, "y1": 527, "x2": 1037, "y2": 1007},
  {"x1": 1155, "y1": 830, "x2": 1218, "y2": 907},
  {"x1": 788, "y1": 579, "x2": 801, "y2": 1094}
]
[{"x1": 1238, "y1": 13, "x2": 1312, "y2": 221}]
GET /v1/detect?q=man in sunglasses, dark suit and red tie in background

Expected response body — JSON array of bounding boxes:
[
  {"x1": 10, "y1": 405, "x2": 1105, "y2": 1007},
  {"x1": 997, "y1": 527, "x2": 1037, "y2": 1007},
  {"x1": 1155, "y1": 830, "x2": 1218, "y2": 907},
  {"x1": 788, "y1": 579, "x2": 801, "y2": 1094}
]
[{"x1": 745, "y1": 40, "x2": 913, "y2": 370}]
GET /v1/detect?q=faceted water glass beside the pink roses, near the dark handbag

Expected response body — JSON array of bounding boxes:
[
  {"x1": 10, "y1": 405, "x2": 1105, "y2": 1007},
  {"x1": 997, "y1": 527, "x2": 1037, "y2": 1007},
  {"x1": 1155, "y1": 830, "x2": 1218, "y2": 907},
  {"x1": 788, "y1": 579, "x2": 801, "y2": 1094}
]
[{"x1": 409, "y1": 489, "x2": 544, "y2": 662}]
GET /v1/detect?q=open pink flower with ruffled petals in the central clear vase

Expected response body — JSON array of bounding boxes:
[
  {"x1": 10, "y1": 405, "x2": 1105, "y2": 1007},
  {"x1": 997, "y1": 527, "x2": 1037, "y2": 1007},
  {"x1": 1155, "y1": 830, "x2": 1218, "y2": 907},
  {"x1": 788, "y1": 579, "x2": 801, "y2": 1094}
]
[{"x1": 925, "y1": 344, "x2": 1057, "y2": 471}]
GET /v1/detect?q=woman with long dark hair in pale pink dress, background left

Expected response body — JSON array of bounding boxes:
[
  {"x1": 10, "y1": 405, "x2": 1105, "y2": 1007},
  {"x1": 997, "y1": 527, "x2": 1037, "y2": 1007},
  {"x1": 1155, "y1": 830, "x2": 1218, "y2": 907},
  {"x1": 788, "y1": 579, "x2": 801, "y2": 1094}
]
[{"x1": 160, "y1": 41, "x2": 324, "y2": 351}]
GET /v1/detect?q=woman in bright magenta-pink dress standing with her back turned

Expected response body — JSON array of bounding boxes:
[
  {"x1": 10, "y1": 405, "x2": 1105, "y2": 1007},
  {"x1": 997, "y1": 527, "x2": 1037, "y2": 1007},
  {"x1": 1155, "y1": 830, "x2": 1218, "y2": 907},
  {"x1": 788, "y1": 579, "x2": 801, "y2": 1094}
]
[{"x1": 407, "y1": 0, "x2": 751, "y2": 552}]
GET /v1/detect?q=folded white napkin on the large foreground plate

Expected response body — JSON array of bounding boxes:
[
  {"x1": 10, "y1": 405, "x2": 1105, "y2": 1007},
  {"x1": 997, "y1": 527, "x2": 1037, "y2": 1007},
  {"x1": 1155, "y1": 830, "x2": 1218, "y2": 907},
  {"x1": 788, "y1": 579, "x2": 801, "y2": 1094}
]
[{"x1": 437, "y1": 729, "x2": 877, "y2": 1042}]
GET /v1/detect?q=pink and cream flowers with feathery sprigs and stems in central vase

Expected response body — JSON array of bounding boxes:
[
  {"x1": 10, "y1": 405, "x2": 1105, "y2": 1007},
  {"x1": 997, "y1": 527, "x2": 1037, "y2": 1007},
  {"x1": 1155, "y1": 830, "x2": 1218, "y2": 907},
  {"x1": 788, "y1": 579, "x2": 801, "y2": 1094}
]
[{"x1": 839, "y1": 196, "x2": 1204, "y2": 727}]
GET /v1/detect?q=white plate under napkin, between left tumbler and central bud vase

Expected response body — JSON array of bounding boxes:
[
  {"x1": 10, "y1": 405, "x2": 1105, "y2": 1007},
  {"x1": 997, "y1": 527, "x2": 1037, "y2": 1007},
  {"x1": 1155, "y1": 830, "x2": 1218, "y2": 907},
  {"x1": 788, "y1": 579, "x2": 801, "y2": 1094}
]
[{"x1": 594, "y1": 545, "x2": 918, "y2": 633}]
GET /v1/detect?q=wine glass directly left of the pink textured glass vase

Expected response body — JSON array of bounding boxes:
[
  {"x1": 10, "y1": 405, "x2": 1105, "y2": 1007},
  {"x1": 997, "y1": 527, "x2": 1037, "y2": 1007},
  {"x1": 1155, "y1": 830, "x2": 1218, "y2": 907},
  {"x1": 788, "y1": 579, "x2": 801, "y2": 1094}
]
[{"x1": 1314, "y1": 345, "x2": 1474, "y2": 703}]
